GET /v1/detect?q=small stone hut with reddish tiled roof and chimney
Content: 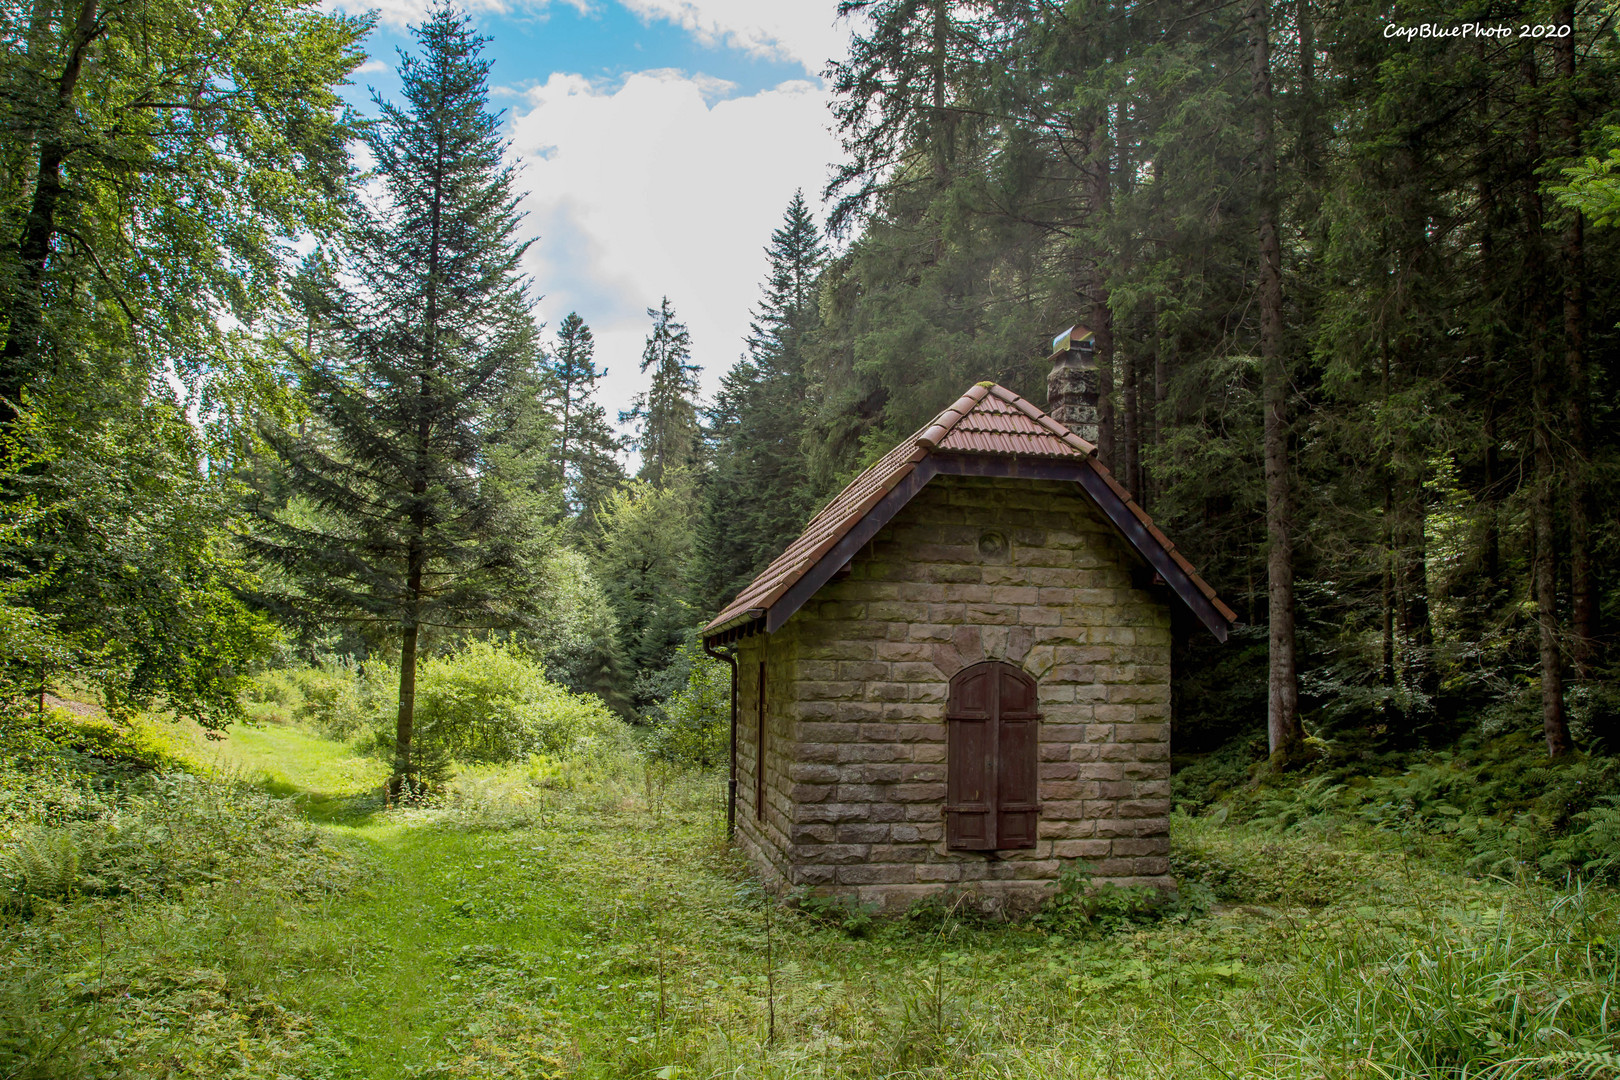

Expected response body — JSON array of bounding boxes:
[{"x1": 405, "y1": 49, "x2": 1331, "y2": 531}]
[{"x1": 703, "y1": 331, "x2": 1234, "y2": 907}]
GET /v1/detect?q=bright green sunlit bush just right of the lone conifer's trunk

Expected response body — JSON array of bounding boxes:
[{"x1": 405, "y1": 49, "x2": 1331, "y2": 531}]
[{"x1": 408, "y1": 641, "x2": 629, "y2": 763}]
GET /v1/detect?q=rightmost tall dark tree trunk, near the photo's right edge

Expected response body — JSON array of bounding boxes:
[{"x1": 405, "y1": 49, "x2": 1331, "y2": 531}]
[{"x1": 1552, "y1": 2, "x2": 1599, "y2": 678}]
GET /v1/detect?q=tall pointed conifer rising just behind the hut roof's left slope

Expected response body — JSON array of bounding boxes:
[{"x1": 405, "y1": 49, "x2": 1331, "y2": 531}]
[{"x1": 697, "y1": 191, "x2": 826, "y2": 609}]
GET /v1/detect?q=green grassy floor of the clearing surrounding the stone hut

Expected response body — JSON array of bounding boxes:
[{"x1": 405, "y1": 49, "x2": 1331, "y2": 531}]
[{"x1": 0, "y1": 712, "x2": 1620, "y2": 1080}]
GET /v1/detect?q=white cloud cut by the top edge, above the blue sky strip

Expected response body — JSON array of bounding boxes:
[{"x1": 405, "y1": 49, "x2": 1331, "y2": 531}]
[{"x1": 619, "y1": 0, "x2": 849, "y2": 74}]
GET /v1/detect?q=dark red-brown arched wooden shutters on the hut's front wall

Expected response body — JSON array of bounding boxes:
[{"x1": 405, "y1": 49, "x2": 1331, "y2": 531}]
[{"x1": 944, "y1": 661, "x2": 1040, "y2": 852}]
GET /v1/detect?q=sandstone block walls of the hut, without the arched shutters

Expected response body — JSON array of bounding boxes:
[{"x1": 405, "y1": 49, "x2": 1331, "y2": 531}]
[{"x1": 737, "y1": 476, "x2": 1171, "y2": 907}]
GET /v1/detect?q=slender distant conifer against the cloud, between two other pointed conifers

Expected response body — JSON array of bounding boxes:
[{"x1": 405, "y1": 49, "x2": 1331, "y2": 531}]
[{"x1": 619, "y1": 296, "x2": 703, "y2": 487}]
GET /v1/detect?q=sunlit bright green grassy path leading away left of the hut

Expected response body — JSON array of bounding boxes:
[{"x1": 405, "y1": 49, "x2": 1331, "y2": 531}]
[{"x1": 220, "y1": 727, "x2": 599, "y2": 1078}]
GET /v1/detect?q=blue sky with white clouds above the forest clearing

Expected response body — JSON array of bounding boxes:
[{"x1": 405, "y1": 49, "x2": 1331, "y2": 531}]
[{"x1": 329, "y1": 0, "x2": 849, "y2": 446}]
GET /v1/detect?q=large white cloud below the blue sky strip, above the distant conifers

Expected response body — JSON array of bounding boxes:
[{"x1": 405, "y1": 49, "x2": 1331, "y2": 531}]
[{"x1": 512, "y1": 71, "x2": 839, "y2": 433}]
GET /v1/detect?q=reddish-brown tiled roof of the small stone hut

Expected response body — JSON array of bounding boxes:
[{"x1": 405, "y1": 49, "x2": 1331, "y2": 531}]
[{"x1": 703, "y1": 382, "x2": 1236, "y2": 635}]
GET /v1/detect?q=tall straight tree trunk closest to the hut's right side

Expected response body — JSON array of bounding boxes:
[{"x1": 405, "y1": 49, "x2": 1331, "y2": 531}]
[{"x1": 1247, "y1": 0, "x2": 1304, "y2": 761}]
